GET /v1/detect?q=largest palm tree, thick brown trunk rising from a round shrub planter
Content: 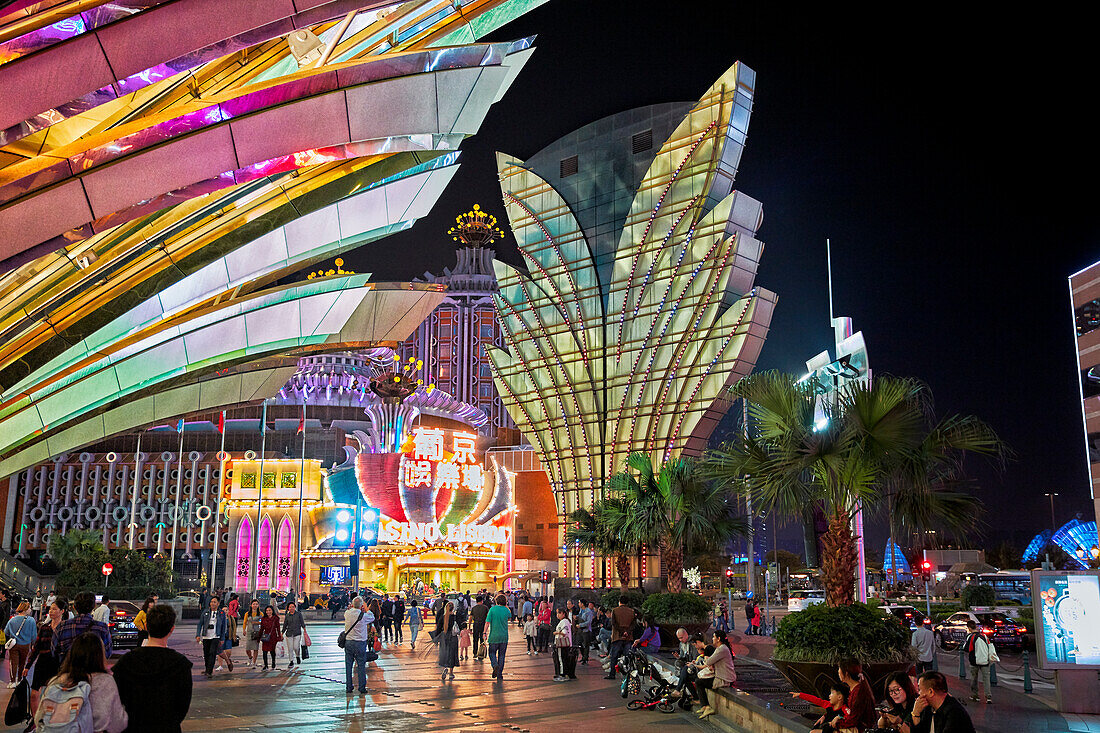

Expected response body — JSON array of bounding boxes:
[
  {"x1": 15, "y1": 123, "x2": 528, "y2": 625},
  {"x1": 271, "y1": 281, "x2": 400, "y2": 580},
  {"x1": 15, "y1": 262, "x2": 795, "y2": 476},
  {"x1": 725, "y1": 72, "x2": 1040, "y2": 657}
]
[{"x1": 705, "y1": 372, "x2": 1005, "y2": 605}]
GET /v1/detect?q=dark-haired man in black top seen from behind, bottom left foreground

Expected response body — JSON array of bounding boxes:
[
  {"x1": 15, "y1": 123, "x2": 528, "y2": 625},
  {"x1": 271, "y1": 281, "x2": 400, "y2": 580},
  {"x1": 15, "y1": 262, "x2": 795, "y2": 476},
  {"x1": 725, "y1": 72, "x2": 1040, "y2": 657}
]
[{"x1": 111, "y1": 604, "x2": 191, "y2": 733}]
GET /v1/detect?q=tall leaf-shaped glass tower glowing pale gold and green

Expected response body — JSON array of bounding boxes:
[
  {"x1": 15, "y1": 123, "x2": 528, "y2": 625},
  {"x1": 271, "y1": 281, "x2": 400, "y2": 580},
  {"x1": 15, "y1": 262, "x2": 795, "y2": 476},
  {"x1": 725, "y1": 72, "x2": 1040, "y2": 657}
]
[{"x1": 488, "y1": 64, "x2": 776, "y2": 586}]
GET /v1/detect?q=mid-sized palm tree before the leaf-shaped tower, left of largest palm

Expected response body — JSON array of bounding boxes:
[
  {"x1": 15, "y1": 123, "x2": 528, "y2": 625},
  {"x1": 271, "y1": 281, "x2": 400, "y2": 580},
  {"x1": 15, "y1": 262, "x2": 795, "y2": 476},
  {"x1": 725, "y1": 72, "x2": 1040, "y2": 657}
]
[{"x1": 603, "y1": 451, "x2": 747, "y2": 593}]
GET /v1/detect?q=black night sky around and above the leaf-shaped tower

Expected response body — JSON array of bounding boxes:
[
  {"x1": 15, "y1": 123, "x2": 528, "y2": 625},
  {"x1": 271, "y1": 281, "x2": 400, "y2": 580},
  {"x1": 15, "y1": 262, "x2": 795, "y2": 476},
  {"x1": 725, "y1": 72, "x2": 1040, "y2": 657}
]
[{"x1": 345, "y1": 0, "x2": 1100, "y2": 549}]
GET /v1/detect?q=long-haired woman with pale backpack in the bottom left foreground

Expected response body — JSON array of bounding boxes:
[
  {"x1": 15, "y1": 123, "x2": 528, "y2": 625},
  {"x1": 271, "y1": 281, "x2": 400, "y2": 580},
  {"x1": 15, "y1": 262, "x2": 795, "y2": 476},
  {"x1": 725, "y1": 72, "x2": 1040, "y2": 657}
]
[{"x1": 34, "y1": 632, "x2": 130, "y2": 733}]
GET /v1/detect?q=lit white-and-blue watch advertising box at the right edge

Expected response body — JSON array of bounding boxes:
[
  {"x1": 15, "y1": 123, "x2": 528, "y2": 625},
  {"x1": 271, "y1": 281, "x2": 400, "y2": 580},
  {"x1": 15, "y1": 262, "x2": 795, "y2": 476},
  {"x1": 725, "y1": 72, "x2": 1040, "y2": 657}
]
[{"x1": 1032, "y1": 570, "x2": 1100, "y2": 669}]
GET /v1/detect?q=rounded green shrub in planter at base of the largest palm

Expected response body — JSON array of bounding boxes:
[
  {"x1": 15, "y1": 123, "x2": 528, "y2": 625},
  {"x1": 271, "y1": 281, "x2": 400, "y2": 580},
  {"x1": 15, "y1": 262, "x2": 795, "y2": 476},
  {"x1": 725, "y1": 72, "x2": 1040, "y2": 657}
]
[{"x1": 774, "y1": 603, "x2": 913, "y2": 665}]
